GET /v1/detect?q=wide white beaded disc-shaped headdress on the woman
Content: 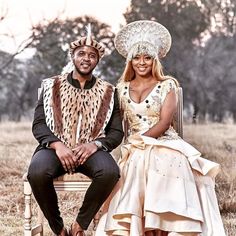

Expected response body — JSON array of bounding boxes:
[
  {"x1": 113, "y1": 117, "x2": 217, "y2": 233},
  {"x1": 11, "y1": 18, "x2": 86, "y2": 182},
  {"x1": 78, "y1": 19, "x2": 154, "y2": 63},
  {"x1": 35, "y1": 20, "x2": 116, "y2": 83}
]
[{"x1": 115, "y1": 20, "x2": 171, "y2": 61}]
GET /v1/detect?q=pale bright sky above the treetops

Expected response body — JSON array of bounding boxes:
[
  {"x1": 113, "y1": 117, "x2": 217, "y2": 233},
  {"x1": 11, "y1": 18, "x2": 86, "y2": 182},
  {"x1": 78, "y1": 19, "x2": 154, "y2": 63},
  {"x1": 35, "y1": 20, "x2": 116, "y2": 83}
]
[{"x1": 0, "y1": 0, "x2": 130, "y2": 53}]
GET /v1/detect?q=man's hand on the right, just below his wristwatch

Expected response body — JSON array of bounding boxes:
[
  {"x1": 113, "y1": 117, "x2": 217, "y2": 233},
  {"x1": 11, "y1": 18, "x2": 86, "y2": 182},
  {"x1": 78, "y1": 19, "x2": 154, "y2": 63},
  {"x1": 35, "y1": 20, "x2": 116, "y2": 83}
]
[{"x1": 72, "y1": 143, "x2": 98, "y2": 165}]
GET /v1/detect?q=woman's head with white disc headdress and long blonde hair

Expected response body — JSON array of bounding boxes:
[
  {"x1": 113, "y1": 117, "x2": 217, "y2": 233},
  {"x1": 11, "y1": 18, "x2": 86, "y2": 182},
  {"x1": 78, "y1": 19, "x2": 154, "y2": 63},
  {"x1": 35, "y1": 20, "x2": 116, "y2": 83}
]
[{"x1": 115, "y1": 20, "x2": 171, "y2": 81}]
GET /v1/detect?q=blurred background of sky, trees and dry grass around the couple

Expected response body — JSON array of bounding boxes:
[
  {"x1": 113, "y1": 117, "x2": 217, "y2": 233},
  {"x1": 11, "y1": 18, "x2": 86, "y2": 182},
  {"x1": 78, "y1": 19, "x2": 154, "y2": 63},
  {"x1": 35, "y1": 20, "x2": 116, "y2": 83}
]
[{"x1": 0, "y1": 0, "x2": 236, "y2": 236}]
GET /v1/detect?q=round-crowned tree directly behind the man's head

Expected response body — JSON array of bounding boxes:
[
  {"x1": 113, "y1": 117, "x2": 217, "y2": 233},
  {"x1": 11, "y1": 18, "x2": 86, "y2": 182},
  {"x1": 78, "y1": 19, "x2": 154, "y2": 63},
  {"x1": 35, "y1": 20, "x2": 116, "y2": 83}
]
[{"x1": 28, "y1": 16, "x2": 114, "y2": 79}]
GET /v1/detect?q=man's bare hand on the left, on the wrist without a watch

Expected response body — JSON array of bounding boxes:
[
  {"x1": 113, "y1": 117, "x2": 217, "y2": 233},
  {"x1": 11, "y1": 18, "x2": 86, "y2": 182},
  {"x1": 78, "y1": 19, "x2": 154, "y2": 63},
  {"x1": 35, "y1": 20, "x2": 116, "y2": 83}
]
[{"x1": 50, "y1": 141, "x2": 77, "y2": 174}]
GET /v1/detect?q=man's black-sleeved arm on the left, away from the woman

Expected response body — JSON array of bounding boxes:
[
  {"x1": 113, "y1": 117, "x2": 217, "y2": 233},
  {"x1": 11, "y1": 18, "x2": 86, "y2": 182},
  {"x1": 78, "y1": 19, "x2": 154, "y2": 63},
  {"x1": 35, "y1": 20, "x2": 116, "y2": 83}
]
[{"x1": 32, "y1": 91, "x2": 60, "y2": 147}]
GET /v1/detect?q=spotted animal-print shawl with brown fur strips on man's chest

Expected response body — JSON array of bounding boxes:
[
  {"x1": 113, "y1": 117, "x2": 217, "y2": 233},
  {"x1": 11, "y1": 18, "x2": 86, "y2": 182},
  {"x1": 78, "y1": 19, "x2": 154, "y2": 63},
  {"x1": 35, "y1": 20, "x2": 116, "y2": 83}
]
[{"x1": 43, "y1": 74, "x2": 115, "y2": 148}]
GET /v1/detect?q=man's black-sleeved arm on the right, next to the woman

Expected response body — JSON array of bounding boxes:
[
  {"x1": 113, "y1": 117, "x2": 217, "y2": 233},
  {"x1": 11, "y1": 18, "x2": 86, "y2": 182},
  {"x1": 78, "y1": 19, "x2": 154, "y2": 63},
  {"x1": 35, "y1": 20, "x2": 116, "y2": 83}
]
[{"x1": 96, "y1": 90, "x2": 124, "y2": 151}]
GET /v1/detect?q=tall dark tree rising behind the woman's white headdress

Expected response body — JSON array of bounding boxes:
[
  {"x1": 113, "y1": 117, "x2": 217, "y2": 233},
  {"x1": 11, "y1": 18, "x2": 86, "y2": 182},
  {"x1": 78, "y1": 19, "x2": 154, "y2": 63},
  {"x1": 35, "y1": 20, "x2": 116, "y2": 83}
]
[{"x1": 120, "y1": 0, "x2": 210, "y2": 121}]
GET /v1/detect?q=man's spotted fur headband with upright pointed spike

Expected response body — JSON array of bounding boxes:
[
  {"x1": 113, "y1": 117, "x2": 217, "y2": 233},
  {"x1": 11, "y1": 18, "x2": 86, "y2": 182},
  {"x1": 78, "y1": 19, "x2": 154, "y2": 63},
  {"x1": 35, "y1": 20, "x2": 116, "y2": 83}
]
[{"x1": 70, "y1": 24, "x2": 105, "y2": 58}]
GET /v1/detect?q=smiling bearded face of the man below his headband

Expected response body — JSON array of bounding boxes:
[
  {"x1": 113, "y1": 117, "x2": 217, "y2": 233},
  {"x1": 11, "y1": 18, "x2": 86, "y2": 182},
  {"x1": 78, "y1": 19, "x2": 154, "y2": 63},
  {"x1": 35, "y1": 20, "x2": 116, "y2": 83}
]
[{"x1": 72, "y1": 46, "x2": 98, "y2": 75}]
